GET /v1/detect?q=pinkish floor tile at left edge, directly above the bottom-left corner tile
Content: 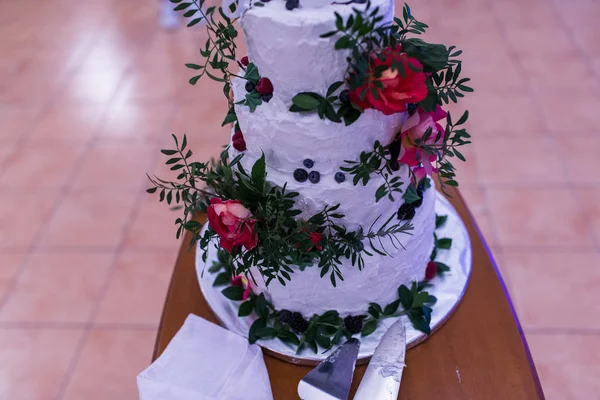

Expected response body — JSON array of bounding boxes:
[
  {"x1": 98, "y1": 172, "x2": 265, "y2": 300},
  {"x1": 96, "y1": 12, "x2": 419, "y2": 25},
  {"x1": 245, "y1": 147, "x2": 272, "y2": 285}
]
[{"x1": 0, "y1": 253, "x2": 114, "y2": 322}]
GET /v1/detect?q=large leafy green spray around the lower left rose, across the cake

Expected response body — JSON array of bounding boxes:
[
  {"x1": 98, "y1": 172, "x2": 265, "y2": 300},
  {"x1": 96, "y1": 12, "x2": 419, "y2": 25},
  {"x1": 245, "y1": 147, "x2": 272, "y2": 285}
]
[{"x1": 147, "y1": 139, "x2": 413, "y2": 286}]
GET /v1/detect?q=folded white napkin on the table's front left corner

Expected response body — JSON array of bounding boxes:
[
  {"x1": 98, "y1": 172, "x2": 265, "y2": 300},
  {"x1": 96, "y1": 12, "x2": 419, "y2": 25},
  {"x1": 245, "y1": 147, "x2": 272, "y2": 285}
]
[{"x1": 137, "y1": 314, "x2": 273, "y2": 400}]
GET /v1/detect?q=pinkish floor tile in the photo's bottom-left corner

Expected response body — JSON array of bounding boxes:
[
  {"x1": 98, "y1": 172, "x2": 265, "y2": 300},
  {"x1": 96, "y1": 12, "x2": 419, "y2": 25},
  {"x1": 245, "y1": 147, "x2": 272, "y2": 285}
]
[{"x1": 0, "y1": 329, "x2": 82, "y2": 400}]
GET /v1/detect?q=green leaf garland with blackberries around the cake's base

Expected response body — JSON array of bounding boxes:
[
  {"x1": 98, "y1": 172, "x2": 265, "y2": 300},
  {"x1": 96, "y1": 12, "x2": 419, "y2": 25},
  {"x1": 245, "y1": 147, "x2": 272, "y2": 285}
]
[{"x1": 208, "y1": 215, "x2": 452, "y2": 353}]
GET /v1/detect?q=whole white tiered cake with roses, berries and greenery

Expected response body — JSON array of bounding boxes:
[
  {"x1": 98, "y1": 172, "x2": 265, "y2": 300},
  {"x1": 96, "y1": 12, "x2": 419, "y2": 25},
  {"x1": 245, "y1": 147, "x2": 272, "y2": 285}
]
[{"x1": 149, "y1": 0, "x2": 472, "y2": 351}]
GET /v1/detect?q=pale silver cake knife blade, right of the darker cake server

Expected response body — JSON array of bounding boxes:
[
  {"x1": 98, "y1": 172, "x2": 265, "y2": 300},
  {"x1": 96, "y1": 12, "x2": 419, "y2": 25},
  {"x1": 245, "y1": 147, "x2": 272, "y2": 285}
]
[{"x1": 354, "y1": 318, "x2": 406, "y2": 400}]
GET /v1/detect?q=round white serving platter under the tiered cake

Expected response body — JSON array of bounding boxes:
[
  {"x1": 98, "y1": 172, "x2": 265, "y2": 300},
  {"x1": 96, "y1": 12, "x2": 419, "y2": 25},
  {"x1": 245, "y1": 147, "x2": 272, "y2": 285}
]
[{"x1": 196, "y1": 192, "x2": 471, "y2": 365}]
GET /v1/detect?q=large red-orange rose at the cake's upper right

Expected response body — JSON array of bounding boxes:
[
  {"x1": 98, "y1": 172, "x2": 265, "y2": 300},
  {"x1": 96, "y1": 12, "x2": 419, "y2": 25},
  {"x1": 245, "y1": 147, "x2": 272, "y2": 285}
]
[{"x1": 350, "y1": 45, "x2": 427, "y2": 115}]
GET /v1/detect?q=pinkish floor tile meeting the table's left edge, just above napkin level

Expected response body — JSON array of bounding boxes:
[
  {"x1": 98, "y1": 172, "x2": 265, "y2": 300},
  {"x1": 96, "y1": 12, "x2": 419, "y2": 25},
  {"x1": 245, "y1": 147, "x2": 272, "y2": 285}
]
[{"x1": 96, "y1": 252, "x2": 175, "y2": 326}]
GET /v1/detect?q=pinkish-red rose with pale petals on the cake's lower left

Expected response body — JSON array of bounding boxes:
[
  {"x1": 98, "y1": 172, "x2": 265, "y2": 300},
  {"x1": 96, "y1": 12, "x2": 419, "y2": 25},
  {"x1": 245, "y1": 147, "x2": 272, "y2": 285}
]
[{"x1": 208, "y1": 197, "x2": 258, "y2": 253}]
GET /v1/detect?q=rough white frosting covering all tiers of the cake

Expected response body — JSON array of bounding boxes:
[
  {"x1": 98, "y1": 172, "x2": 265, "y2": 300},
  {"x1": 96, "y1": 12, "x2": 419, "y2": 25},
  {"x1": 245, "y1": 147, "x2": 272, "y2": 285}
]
[{"x1": 231, "y1": 0, "x2": 435, "y2": 317}]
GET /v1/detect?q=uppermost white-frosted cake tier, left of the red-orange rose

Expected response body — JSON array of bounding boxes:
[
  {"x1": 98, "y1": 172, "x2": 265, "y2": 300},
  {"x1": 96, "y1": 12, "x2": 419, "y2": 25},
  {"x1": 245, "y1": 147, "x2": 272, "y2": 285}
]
[{"x1": 241, "y1": 0, "x2": 394, "y2": 99}]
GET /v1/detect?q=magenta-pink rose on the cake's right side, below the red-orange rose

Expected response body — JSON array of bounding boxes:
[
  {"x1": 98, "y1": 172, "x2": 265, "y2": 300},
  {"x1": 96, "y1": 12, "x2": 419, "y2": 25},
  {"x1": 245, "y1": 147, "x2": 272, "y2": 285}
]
[{"x1": 398, "y1": 105, "x2": 446, "y2": 175}]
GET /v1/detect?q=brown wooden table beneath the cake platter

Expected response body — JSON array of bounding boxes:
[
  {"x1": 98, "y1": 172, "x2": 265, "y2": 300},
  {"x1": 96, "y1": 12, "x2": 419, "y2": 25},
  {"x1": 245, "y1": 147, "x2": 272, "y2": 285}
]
[{"x1": 153, "y1": 190, "x2": 544, "y2": 400}]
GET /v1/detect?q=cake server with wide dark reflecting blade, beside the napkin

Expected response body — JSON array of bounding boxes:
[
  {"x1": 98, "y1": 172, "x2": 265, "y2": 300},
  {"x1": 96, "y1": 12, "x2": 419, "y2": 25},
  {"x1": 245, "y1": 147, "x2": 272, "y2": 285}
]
[{"x1": 298, "y1": 339, "x2": 360, "y2": 400}]
